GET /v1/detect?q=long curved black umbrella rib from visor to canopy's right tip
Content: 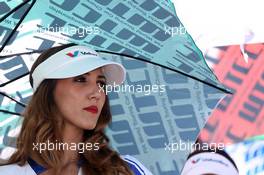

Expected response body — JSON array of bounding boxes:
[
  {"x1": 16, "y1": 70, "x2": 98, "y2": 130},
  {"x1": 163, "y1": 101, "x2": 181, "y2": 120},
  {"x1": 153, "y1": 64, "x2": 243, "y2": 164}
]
[{"x1": 96, "y1": 50, "x2": 233, "y2": 94}]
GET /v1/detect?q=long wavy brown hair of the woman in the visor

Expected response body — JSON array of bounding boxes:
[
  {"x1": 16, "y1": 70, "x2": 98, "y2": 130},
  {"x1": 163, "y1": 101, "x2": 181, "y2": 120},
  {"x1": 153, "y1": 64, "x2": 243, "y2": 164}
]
[{"x1": 5, "y1": 44, "x2": 132, "y2": 175}]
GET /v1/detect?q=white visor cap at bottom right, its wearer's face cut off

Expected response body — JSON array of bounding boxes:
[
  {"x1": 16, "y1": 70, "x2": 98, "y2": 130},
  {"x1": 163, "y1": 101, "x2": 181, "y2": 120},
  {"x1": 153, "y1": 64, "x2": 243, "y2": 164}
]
[{"x1": 181, "y1": 152, "x2": 239, "y2": 175}]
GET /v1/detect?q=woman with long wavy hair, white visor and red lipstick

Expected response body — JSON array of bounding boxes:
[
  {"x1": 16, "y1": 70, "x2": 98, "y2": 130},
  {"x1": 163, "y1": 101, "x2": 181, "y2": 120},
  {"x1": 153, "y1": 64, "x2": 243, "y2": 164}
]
[{"x1": 0, "y1": 44, "x2": 151, "y2": 175}]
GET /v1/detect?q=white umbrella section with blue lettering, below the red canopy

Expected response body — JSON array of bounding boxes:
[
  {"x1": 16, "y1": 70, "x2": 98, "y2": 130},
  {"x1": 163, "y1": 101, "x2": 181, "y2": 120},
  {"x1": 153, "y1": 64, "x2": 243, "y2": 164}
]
[{"x1": 226, "y1": 135, "x2": 264, "y2": 175}]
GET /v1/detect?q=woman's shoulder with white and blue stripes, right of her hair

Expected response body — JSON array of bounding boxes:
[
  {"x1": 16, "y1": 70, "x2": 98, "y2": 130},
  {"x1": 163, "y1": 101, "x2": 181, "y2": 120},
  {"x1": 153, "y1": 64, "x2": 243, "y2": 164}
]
[{"x1": 121, "y1": 155, "x2": 152, "y2": 175}]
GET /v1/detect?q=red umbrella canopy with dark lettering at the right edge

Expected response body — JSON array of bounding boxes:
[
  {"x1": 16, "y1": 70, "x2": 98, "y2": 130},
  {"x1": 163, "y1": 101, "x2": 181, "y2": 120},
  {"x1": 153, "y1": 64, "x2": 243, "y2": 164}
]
[{"x1": 200, "y1": 43, "x2": 264, "y2": 143}]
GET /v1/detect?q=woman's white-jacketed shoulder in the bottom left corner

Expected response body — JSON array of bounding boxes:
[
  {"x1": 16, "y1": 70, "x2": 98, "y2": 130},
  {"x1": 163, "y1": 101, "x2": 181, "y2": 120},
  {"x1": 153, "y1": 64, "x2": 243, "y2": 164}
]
[{"x1": 0, "y1": 163, "x2": 36, "y2": 175}]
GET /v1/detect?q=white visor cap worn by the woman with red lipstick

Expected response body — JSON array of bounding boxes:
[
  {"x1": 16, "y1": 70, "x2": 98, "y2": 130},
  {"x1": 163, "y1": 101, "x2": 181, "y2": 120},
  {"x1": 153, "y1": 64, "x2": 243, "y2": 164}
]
[{"x1": 32, "y1": 46, "x2": 126, "y2": 91}]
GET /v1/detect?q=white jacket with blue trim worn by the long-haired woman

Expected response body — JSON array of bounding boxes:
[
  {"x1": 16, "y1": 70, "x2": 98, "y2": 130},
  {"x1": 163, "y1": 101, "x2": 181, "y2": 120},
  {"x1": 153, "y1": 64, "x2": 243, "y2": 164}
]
[{"x1": 0, "y1": 155, "x2": 152, "y2": 175}]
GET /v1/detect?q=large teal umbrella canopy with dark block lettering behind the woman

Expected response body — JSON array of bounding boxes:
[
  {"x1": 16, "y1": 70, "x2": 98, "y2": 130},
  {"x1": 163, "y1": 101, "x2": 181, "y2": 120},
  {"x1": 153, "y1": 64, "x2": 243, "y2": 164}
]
[{"x1": 0, "y1": 0, "x2": 230, "y2": 175}]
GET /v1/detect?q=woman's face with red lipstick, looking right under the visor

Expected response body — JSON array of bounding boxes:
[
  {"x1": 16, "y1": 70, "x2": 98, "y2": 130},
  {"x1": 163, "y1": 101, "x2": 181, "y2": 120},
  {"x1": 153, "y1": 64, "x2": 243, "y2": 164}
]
[{"x1": 54, "y1": 68, "x2": 106, "y2": 129}]
